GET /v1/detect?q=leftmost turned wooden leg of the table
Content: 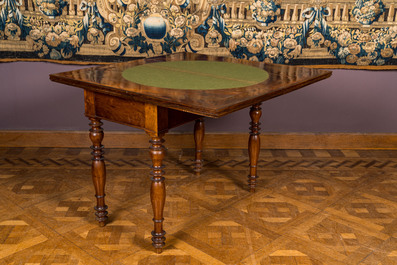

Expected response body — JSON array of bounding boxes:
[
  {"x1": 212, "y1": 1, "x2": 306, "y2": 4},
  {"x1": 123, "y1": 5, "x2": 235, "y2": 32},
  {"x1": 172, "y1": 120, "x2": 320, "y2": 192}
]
[{"x1": 90, "y1": 118, "x2": 108, "y2": 226}]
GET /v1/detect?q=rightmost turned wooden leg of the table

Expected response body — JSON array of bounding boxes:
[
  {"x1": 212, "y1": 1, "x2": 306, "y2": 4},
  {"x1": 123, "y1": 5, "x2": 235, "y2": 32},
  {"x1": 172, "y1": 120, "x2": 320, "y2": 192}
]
[{"x1": 248, "y1": 103, "x2": 262, "y2": 192}]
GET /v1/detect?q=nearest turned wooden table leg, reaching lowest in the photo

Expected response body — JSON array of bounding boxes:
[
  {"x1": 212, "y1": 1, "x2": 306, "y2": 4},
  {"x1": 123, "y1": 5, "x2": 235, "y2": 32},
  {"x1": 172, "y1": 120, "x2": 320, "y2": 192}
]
[{"x1": 149, "y1": 136, "x2": 165, "y2": 254}]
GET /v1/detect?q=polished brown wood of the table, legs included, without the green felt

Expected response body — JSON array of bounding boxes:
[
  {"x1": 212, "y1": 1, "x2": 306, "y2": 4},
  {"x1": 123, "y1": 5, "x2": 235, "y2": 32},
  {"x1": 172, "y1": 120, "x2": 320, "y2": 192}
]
[{"x1": 50, "y1": 53, "x2": 331, "y2": 253}]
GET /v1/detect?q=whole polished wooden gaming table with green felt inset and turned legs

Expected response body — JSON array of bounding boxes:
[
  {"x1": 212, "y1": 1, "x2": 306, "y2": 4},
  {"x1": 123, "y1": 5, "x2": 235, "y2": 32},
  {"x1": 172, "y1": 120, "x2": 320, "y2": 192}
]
[{"x1": 50, "y1": 53, "x2": 331, "y2": 253}]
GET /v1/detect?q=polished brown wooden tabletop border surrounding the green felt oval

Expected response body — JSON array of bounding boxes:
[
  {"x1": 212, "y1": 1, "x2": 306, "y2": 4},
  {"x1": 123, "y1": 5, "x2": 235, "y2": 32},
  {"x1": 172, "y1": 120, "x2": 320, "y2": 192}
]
[{"x1": 50, "y1": 53, "x2": 332, "y2": 118}]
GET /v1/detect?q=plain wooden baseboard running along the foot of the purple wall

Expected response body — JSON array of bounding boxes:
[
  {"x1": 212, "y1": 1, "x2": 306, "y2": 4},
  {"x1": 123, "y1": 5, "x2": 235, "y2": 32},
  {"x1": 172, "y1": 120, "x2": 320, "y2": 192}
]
[{"x1": 0, "y1": 131, "x2": 397, "y2": 149}]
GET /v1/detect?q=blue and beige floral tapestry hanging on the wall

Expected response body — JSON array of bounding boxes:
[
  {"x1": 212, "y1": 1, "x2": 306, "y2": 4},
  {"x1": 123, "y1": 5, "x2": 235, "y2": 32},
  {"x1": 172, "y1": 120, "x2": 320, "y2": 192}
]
[{"x1": 0, "y1": 0, "x2": 397, "y2": 69}]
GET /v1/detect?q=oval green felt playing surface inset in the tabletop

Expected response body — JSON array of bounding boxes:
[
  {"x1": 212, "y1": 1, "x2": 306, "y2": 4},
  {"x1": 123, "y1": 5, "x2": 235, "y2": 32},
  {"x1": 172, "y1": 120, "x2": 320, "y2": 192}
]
[{"x1": 122, "y1": 61, "x2": 269, "y2": 90}]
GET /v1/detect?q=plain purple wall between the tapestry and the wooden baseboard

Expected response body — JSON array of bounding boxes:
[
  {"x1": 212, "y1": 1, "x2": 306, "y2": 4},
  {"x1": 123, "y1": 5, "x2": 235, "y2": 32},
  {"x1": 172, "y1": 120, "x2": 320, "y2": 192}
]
[{"x1": 0, "y1": 62, "x2": 397, "y2": 133}]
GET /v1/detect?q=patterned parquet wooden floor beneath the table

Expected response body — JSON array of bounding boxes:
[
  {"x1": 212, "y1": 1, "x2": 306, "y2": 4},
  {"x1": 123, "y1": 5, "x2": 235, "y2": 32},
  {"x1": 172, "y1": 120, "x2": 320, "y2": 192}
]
[{"x1": 0, "y1": 148, "x2": 397, "y2": 265}]
